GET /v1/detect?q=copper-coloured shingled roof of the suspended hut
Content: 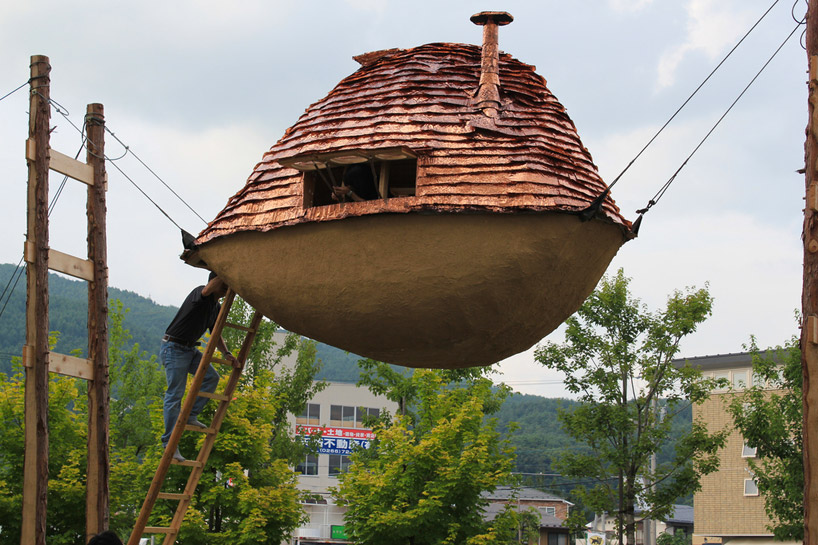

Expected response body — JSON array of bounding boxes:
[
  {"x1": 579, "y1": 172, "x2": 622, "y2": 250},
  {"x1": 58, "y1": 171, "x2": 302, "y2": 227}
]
[{"x1": 196, "y1": 43, "x2": 630, "y2": 244}]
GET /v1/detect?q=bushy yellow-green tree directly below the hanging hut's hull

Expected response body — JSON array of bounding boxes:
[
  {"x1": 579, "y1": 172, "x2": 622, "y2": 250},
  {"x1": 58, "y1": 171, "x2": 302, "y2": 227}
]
[{"x1": 335, "y1": 361, "x2": 517, "y2": 545}]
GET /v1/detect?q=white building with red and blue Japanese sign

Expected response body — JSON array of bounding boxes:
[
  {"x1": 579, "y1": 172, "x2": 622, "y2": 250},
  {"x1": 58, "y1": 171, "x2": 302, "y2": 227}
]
[{"x1": 291, "y1": 382, "x2": 398, "y2": 545}]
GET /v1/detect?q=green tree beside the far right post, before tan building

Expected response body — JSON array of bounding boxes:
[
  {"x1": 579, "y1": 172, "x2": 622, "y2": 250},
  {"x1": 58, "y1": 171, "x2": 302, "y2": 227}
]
[{"x1": 730, "y1": 337, "x2": 804, "y2": 541}]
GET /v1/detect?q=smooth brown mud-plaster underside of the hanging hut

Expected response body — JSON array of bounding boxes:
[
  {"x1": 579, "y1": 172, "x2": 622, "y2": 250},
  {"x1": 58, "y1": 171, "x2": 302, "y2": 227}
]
[{"x1": 194, "y1": 213, "x2": 624, "y2": 368}]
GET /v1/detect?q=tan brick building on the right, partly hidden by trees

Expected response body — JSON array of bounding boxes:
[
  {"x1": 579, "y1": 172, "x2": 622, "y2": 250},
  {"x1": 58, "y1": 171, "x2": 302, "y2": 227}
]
[{"x1": 674, "y1": 352, "x2": 796, "y2": 545}]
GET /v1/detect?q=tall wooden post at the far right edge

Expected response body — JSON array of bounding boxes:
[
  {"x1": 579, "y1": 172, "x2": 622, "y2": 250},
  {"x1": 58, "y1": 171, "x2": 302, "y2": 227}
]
[{"x1": 801, "y1": 4, "x2": 818, "y2": 545}]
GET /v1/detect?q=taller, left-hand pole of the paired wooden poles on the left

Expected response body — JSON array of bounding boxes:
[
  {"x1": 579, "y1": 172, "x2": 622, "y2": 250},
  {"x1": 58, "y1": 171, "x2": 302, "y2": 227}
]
[{"x1": 20, "y1": 55, "x2": 51, "y2": 545}]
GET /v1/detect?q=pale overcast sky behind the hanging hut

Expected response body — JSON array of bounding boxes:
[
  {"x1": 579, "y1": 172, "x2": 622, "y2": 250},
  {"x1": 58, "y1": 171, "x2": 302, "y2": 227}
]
[{"x1": 0, "y1": 0, "x2": 807, "y2": 396}]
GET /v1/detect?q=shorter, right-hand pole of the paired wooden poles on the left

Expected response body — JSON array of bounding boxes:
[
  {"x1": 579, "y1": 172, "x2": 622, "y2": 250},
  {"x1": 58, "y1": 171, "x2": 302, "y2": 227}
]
[{"x1": 85, "y1": 104, "x2": 109, "y2": 538}]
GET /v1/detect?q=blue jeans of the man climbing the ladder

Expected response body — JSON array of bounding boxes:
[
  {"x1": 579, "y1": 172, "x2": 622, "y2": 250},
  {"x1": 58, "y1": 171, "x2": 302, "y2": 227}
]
[{"x1": 159, "y1": 341, "x2": 219, "y2": 445}]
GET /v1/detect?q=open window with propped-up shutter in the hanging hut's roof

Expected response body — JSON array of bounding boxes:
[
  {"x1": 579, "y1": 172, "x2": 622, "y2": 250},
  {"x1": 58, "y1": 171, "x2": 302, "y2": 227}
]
[{"x1": 279, "y1": 147, "x2": 417, "y2": 208}]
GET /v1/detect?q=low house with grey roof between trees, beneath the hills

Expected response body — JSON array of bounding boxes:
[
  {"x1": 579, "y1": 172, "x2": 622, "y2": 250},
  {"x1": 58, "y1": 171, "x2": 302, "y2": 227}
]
[{"x1": 483, "y1": 486, "x2": 574, "y2": 545}]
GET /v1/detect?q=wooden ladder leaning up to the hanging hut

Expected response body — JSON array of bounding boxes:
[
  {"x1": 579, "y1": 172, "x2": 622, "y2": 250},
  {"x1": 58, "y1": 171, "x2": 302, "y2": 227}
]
[{"x1": 128, "y1": 289, "x2": 262, "y2": 545}]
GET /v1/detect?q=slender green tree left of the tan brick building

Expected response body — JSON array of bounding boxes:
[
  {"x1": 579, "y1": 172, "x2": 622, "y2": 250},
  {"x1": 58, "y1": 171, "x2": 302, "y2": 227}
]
[{"x1": 535, "y1": 269, "x2": 726, "y2": 544}]
